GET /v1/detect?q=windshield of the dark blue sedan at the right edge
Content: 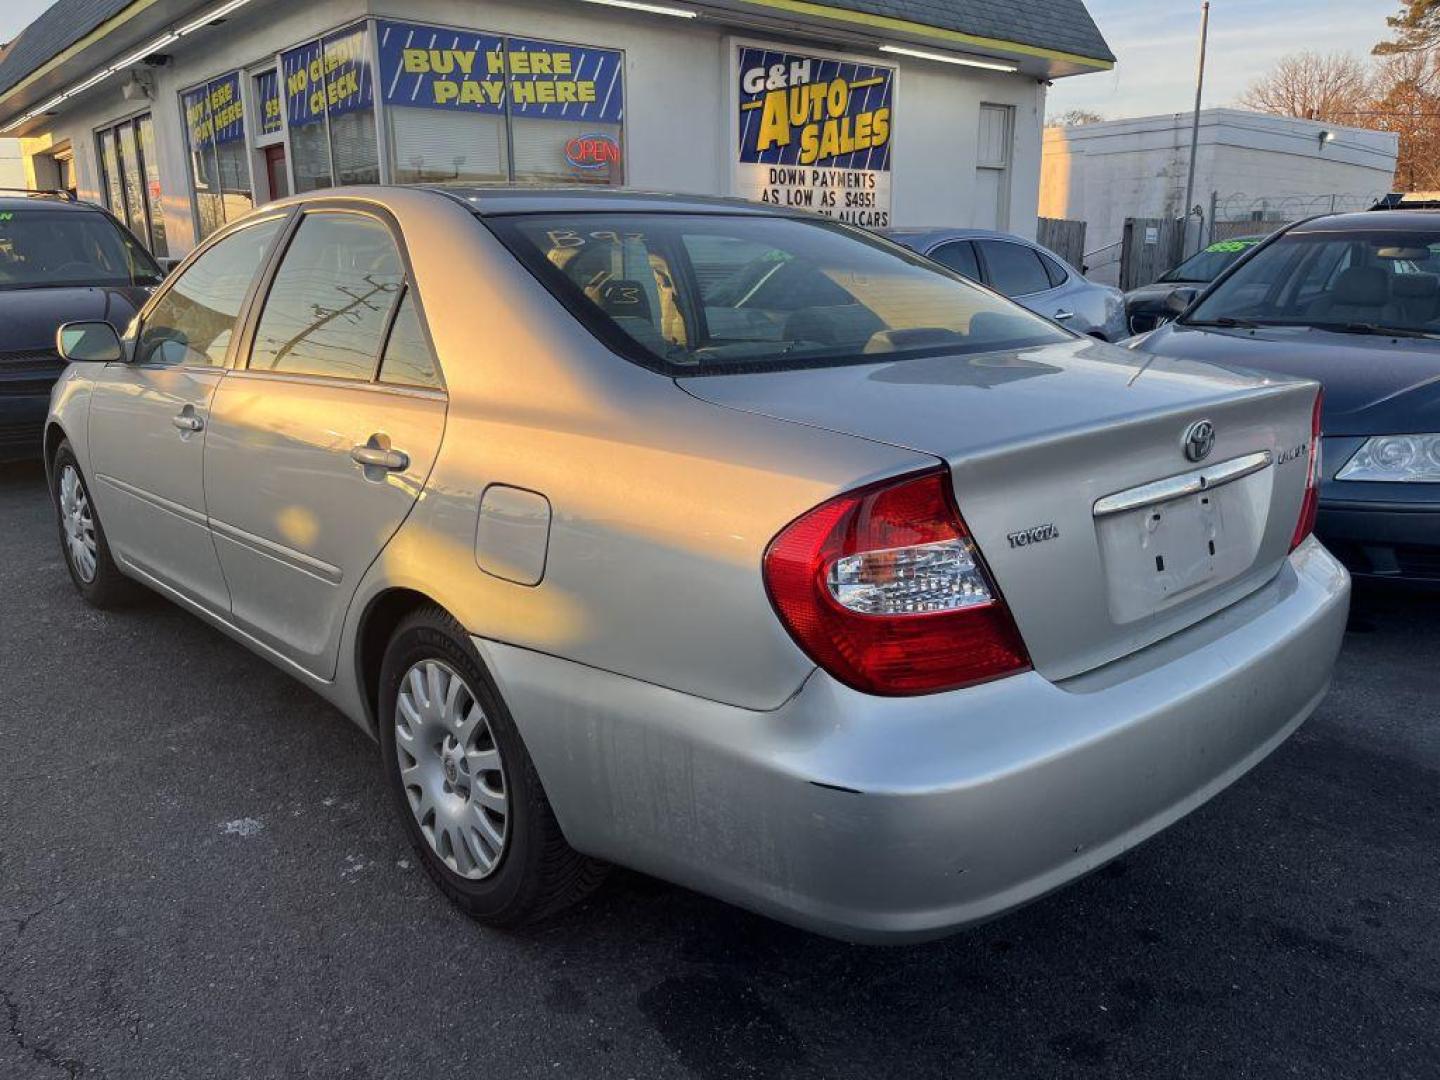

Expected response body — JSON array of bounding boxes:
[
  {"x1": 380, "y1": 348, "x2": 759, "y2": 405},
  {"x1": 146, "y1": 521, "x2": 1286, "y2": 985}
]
[{"x1": 1184, "y1": 223, "x2": 1440, "y2": 334}]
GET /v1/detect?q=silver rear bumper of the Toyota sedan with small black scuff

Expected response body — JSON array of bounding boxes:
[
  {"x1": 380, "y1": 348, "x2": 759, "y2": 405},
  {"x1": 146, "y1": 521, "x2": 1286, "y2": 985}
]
[{"x1": 477, "y1": 540, "x2": 1349, "y2": 942}]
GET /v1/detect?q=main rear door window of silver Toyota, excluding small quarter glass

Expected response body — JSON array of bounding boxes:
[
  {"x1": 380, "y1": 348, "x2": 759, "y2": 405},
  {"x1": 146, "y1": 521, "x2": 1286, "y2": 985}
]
[{"x1": 251, "y1": 212, "x2": 405, "y2": 382}]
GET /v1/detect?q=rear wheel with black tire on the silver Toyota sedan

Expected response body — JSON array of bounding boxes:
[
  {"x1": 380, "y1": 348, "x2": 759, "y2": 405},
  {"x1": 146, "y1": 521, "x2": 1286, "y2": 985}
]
[{"x1": 379, "y1": 605, "x2": 606, "y2": 926}]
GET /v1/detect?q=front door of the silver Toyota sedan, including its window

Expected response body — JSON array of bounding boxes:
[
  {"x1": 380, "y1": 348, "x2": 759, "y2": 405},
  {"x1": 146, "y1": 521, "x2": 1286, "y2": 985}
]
[{"x1": 88, "y1": 216, "x2": 285, "y2": 612}]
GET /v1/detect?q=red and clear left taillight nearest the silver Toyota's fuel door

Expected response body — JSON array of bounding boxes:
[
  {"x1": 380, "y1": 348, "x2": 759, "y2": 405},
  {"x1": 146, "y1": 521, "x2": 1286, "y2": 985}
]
[{"x1": 765, "y1": 469, "x2": 1030, "y2": 694}]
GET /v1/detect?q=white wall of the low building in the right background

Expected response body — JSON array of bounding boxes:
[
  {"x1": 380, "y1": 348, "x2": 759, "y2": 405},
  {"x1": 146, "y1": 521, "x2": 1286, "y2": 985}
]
[{"x1": 1040, "y1": 109, "x2": 1397, "y2": 279}]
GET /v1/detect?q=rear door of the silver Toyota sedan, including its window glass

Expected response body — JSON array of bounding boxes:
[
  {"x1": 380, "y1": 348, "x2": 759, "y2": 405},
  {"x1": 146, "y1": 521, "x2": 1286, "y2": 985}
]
[{"x1": 204, "y1": 206, "x2": 446, "y2": 678}]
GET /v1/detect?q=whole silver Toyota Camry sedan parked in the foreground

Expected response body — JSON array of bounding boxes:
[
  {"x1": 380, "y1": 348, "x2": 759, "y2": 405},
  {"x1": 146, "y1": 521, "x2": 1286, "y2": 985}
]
[{"x1": 45, "y1": 187, "x2": 1349, "y2": 942}]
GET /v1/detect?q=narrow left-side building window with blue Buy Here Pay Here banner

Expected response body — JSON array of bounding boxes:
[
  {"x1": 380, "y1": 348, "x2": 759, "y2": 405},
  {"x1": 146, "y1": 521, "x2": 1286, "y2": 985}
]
[{"x1": 180, "y1": 72, "x2": 255, "y2": 240}]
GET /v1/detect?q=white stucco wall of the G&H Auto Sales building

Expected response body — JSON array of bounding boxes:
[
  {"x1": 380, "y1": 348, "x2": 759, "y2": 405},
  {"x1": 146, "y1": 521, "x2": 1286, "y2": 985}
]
[{"x1": 16, "y1": 0, "x2": 1044, "y2": 255}]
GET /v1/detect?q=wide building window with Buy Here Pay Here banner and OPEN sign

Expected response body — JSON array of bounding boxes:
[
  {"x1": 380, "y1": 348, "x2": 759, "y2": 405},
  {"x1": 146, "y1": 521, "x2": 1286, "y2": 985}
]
[{"x1": 377, "y1": 20, "x2": 625, "y2": 184}]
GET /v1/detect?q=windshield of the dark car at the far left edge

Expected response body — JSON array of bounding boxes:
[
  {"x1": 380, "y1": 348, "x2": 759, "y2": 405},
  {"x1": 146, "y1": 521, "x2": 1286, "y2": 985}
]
[{"x1": 0, "y1": 209, "x2": 164, "y2": 289}]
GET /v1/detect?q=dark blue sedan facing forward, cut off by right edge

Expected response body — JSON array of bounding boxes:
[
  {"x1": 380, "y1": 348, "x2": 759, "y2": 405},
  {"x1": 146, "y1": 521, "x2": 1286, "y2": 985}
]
[{"x1": 1132, "y1": 210, "x2": 1440, "y2": 586}]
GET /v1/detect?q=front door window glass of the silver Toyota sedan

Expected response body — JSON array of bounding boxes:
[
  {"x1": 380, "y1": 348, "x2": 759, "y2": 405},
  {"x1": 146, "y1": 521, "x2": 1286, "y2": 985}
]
[{"x1": 135, "y1": 217, "x2": 284, "y2": 367}]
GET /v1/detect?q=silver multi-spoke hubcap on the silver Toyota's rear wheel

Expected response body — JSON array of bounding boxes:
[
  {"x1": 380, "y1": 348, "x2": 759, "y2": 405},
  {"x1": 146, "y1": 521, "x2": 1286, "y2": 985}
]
[{"x1": 395, "y1": 660, "x2": 510, "y2": 878}]
